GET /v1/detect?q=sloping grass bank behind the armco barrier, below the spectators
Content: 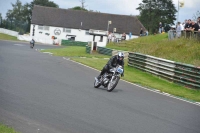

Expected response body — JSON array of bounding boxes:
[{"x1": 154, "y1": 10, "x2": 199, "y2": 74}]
[{"x1": 107, "y1": 34, "x2": 200, "y2": 66}]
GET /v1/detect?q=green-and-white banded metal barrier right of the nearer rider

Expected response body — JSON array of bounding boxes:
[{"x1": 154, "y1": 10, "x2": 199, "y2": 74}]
[{"x1": 128, "y1": 52, "x2": 200, "y2": 89}]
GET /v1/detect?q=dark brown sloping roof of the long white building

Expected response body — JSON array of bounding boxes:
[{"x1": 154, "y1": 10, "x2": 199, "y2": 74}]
[{"x1": 31, "y1": 5, "x2": 145, "y2": 35}]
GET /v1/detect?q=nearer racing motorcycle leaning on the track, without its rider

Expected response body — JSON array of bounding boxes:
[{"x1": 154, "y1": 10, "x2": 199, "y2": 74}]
[{"x1": 94, "y1": 65, "x2": 124, "y2": 92}]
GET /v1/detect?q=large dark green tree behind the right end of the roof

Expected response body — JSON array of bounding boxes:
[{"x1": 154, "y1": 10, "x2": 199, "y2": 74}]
[{"x1": 136, "y1": 0, "x2": 177, "y2": 33}]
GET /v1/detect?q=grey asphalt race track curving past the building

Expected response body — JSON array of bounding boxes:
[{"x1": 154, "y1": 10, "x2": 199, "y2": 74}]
[{"x1": 0, "y1": 40, "x2": 200, "y2": 133}]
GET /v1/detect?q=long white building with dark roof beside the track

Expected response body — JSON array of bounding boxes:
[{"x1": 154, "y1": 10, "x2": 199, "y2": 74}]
[{"x1": 30, "y1": 5, "x2": 144, "y2": 46}]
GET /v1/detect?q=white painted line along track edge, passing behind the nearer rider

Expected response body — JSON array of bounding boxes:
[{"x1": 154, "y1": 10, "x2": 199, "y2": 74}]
[{"x1": 63, "y1": 57, "x2": 200, "y2": 106}]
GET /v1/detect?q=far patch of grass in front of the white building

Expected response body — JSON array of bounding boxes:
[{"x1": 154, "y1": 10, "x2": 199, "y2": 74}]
[{"x1": 42, "y1": 46, "x2": 109, "y2": 58}]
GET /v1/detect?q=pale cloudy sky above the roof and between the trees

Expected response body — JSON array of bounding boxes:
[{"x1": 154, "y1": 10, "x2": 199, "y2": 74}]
[{"x1": 0, "y1": 0, "x2": 200, "y2": 22}]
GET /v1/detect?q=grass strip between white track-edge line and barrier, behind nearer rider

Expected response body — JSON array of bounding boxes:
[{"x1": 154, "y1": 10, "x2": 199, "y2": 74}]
[{"x1": 71, "y1": 58, "x2": 200, "y2": 102}]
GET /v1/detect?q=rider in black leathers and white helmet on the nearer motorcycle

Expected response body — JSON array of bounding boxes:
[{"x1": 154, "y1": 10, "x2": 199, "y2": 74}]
[{"x1": 97, "y1": 52, "x2": 124, "y2": 80}]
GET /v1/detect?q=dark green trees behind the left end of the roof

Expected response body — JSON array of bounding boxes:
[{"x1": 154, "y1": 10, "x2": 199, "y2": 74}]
[{"x1": 0, "y1": 0, "x2": 87, "y2": 34}]
